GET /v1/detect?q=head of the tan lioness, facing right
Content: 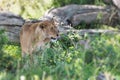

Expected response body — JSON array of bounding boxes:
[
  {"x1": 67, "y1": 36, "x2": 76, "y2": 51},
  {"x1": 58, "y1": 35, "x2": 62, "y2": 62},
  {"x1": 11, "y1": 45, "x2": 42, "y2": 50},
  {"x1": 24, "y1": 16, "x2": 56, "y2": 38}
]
[{"x1": 36, "y1": 20, "x2": 59, "y2": 41}]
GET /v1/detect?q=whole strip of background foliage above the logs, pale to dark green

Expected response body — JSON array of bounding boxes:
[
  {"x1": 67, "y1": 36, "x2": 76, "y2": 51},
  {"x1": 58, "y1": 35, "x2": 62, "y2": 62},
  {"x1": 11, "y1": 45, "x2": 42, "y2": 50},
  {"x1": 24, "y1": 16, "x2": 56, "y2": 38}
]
[{"x1": 0, "y1": 0, "x2": 103, "y2": 19}]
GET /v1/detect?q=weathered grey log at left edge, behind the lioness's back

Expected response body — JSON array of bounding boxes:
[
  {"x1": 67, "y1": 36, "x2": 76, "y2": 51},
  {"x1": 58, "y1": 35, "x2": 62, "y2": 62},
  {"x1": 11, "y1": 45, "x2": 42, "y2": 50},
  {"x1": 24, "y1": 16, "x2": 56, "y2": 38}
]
[{"x1": 0, "y1": 12, "x2": 25, "y2": 43}]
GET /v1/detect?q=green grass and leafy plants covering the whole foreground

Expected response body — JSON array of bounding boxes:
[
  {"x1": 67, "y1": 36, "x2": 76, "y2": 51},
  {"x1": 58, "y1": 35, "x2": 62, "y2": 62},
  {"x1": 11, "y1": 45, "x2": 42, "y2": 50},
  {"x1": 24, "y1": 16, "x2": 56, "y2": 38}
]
[{"x1": 0, "y1": 30, "x2": 120, "y2": 80}]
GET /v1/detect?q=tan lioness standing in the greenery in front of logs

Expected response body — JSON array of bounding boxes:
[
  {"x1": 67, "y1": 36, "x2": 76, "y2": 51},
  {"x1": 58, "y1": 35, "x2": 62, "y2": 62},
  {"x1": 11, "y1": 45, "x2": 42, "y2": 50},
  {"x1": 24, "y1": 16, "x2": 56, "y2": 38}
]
[{"x1": 20, "y1": 19, "x2": 59, "y2": 56}]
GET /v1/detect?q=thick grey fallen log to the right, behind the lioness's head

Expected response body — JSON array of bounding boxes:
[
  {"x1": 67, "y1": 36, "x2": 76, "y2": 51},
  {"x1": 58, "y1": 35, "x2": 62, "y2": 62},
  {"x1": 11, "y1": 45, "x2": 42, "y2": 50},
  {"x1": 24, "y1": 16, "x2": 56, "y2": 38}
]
[{"x1": 41, "y1": 4, "x2": 120, "y2": 26}]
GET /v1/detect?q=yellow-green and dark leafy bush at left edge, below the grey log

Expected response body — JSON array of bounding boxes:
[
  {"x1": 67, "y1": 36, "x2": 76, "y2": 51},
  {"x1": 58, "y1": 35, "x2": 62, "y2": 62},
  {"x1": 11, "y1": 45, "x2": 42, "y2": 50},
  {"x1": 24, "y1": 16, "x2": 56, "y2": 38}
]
[{"x1": 0, "y1": 30, "x2": 20, "y2": 71}]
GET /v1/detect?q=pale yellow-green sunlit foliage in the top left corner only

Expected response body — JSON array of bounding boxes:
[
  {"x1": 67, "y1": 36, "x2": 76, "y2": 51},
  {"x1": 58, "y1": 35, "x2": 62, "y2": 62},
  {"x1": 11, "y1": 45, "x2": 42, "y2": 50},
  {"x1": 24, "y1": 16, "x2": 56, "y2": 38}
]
[{"x1": 0, "y1": 0, "x2": 52, "y2": 19}]
